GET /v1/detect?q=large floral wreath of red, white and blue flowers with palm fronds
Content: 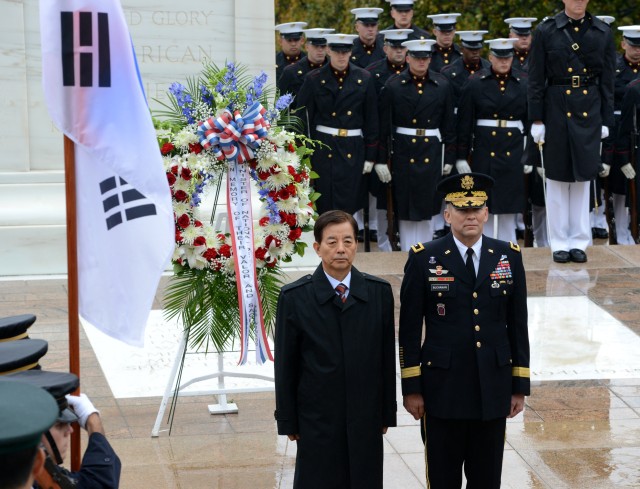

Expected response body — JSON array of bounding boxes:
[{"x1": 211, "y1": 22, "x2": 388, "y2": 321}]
[{"x1": 154, "y1": 63, "x2": 319, "y2": 363}]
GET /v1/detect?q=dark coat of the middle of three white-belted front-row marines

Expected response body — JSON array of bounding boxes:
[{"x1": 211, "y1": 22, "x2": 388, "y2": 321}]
[{"x1": 378, "y1": 70, "x2": 456, "y2": 221}]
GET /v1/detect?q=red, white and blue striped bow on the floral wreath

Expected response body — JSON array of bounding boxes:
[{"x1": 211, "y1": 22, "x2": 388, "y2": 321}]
[{"x1": 198, "y1": 102, "x2": 269, "y2": 163}]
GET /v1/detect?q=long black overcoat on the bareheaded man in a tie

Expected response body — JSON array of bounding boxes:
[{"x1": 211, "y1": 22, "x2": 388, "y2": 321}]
[{"x1": 274, "y1": 265, "x2": 396, "y2": 489}]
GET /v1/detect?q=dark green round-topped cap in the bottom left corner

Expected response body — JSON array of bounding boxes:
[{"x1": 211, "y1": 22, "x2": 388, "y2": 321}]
[{"x1": 0, "y1": 379, "x2": 58, "y2": 455}]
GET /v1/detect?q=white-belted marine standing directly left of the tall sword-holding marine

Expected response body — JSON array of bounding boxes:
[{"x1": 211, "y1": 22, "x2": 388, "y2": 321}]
[{"x1": 456, "y1": 38, "x2": 527, "y2": 243}]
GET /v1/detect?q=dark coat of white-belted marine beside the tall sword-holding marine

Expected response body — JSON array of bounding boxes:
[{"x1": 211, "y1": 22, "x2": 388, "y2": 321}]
[{"x1": 457, "y1": 68, "x2": 527, "y2": 214}]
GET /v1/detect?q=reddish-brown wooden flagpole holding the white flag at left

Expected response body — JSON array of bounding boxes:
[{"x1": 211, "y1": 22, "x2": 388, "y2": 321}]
[{"x1": 64, "y1": 136, "x2": 80, "y2": 471}]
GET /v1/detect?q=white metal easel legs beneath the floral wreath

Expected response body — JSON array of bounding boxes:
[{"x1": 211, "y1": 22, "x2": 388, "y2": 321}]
[{"x1": 151, "y1": 324, "x2": 274, "y2": 438}]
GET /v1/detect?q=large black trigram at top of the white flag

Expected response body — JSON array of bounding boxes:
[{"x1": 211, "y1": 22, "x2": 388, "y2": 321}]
[{"x1": 60, "y1": 12, "x2": 111, "y2": 87}]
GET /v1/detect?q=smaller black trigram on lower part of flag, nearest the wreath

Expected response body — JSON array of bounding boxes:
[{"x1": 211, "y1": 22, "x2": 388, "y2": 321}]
[{"x1": 100, "y1": 177, "x2": 157, "y2": 229}]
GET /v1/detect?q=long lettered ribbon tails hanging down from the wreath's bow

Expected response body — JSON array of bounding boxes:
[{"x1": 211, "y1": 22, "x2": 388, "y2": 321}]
[{"x1": 227, "y1": 161, "x2": 273, "y2": 365}]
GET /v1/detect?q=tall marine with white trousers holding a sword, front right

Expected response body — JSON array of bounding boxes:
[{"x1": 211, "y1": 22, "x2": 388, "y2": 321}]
[{"x1": 528, "y1": 0, "x2": 615, "y2": 263}]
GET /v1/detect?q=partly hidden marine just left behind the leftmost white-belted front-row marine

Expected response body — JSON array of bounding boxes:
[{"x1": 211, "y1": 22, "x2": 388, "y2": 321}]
[{"x1": 278, "y1": 28, "x2": 334, "y2": 104}]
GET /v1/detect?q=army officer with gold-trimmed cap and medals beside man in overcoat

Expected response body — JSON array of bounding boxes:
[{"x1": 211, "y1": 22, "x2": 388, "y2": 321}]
[{"x1": 398, "y1": 173, "x2": 530, "y2": 489}]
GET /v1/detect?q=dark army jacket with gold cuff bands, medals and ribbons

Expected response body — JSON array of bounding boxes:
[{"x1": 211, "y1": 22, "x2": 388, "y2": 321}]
[{"x1": 399, "y1": 233, "x2": 530, "y2": 421}]
